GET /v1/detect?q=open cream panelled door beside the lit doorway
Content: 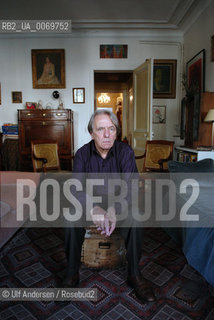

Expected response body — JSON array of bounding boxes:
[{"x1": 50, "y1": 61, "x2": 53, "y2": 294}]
[{"x1": 132, "y1": 59, "x2": 153, "y2": 155}]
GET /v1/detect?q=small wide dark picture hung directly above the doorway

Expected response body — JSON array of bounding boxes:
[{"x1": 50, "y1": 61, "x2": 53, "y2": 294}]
[{"x1": 100, "y1": 44, "x2": 128, "y2": 59}]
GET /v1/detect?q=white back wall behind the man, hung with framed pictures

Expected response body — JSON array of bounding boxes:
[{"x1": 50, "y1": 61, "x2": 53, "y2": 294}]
[{"x1": 0, "y1": 33, "x2": 182, "y2": 150}]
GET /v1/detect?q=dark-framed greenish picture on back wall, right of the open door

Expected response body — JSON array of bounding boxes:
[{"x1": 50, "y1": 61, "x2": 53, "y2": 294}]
[{"x1": 153, "y1": 59, "x2": 177, "y2": 99}]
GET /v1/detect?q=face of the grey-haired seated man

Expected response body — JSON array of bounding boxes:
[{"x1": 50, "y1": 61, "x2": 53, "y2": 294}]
[{"x1": 91, "y1": 114, "x2": 117, "y2": 153}]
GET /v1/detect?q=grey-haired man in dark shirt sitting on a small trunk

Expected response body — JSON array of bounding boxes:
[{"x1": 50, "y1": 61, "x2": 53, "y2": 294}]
[{"x1": 62, "y1": 110, "x2": 155, "y2": 303}]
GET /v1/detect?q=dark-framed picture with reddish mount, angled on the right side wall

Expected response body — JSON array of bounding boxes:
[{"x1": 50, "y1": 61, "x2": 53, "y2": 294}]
[{"x1": 186, "y1": 49, "x2": 205, "y2": 92}]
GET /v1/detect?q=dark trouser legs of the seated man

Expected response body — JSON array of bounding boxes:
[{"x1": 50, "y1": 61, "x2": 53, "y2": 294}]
[{"x1": 65, "y1": 227, "x2": 143, "y2": 277}]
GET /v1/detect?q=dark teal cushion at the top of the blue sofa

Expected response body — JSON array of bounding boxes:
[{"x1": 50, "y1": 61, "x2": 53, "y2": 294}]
[{"x1": 168, "y1": 159, "x2": 214, "y2": 173}]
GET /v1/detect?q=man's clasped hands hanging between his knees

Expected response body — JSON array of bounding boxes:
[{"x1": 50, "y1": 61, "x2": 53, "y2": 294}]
[{"x1": 91, "y1": 206, "x2": 116, "y2": 236}]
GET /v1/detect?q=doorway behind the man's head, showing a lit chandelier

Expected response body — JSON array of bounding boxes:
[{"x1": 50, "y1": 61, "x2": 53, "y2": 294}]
[{"x1": 94, "y1": 71, "x2": 133, "y2": 140}]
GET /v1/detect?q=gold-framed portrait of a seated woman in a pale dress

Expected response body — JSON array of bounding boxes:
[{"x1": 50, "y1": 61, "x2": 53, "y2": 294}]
[{"x1": 31, "y1": 49, "x2": 65, "y2": 89}]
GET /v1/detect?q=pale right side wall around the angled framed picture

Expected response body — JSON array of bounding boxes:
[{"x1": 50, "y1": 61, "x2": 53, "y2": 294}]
[{"x1": 184, "y1": 1, "x2": 214, "y2": 92}]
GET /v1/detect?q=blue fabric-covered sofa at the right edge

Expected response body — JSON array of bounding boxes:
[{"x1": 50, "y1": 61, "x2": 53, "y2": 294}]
[{"x1": 165, "y1": 159, "x2": 214, "y2": 286}]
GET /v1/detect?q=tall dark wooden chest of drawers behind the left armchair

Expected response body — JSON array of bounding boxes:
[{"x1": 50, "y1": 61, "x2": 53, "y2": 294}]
[{"x1": 18, "y1": 109, "x2": 74, "y2": 171}]
